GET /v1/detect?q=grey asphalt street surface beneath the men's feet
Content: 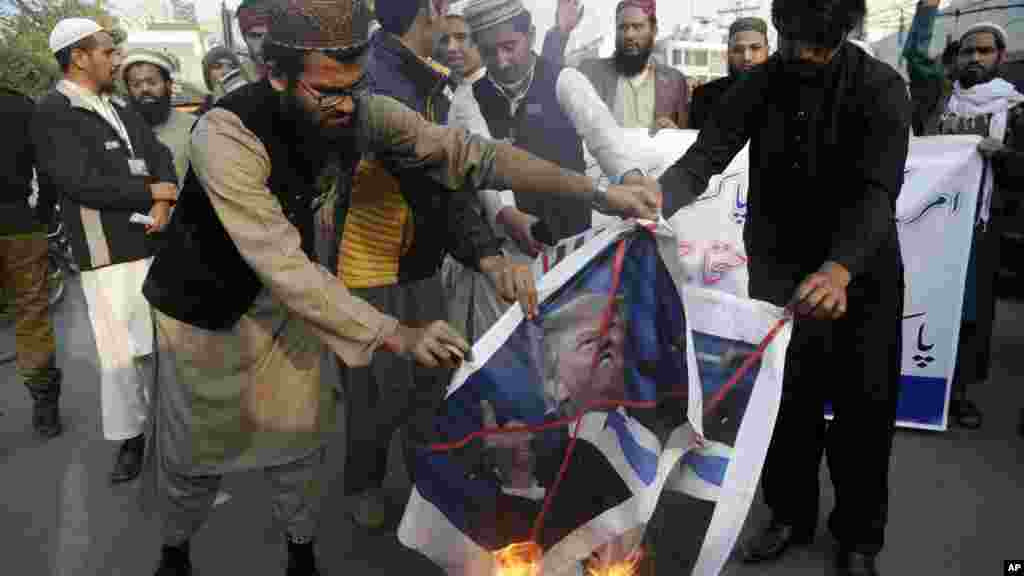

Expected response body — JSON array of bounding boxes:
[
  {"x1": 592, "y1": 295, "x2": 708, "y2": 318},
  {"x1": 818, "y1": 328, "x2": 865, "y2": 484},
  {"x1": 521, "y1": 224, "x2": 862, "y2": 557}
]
[{"x1": 0, "y1": 282, "x2": 1024, "y2": 576}]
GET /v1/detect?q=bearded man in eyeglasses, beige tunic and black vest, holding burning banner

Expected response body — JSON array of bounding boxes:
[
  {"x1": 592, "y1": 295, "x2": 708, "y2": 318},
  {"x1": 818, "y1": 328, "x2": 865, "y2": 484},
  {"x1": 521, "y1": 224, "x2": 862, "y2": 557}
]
[{"x1": 143, "y1": 0, "x2": 659, "y2": 576}]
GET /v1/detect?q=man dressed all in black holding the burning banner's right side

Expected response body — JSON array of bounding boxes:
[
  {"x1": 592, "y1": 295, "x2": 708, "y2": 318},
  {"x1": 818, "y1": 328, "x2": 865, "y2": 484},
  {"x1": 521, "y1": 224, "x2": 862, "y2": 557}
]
[{"x1": 662, "y1": 0, "x2": 910, "y2": 575}]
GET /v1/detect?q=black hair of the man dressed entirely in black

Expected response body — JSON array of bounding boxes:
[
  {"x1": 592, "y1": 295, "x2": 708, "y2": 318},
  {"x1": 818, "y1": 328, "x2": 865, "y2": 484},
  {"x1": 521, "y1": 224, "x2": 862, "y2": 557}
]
[{"x1": 771, "y1": 0, "x2": 867, "y2": 48}]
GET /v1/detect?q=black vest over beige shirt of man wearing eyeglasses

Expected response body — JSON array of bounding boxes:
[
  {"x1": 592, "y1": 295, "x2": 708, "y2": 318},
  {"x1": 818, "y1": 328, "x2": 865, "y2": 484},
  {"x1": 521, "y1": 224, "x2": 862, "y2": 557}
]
[{"x1": 142, "y1": 81, "x2": 367, "y2": 330}]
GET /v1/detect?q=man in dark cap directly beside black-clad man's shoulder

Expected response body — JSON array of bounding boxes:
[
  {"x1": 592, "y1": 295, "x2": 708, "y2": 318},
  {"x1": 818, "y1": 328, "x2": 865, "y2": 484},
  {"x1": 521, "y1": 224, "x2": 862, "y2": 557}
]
[{"x1": 689, "y1": 17, "x2": 768, "y2": 130}]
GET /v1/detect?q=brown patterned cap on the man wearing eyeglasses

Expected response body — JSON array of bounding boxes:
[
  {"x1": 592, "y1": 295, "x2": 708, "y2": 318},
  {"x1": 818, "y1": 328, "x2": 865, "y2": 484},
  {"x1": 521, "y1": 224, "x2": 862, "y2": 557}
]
[{"x1": 266, "y1": 0, "x2": 367, "y2": 57}]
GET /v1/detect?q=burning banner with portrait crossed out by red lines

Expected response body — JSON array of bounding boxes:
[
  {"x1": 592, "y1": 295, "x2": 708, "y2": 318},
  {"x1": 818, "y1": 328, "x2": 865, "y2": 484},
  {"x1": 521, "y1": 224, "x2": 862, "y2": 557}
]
[{"x1": 399, "y1": 216, "x2": 790, "y2": 576}]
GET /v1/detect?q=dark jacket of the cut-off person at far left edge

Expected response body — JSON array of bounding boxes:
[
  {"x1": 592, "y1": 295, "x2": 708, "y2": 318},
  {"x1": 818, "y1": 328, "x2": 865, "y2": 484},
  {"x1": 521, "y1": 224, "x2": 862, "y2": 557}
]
[{"x1": 0, "y1": 88, "x2": 41, "y2": 235}]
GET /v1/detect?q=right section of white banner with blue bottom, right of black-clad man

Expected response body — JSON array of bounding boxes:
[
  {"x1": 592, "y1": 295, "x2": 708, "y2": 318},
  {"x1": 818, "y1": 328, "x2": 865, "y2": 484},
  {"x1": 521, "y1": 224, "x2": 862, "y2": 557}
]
[{"x1": 896, "y1": 136, "x2": 991, "y2": 430}]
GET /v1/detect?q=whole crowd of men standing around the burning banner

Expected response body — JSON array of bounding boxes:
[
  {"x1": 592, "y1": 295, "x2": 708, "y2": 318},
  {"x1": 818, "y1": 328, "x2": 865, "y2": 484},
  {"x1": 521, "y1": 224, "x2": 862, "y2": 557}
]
[{"x1": 0, "y1": 0, "x2": 1024, "y2": 576}]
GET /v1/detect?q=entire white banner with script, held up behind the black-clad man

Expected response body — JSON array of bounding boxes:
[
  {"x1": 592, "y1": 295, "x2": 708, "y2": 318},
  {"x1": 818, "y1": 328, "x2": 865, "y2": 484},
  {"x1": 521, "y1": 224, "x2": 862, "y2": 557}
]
[{"x1": 577, "y1": 116, "x2": 991, "y2": 430}]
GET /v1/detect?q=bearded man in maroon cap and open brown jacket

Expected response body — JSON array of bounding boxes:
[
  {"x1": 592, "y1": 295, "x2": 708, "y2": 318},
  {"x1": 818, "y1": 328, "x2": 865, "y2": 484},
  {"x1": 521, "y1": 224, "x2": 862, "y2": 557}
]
[{"x1": 580, "y1": 0, "x2": 690, "y2": 130}]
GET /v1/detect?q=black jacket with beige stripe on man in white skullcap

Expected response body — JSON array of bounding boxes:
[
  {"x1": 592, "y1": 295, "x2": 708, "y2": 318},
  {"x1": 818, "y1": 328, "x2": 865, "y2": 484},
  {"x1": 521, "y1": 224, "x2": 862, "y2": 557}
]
[{"x1": 32, "y1": 81, "x2": 178, "y2": 270}]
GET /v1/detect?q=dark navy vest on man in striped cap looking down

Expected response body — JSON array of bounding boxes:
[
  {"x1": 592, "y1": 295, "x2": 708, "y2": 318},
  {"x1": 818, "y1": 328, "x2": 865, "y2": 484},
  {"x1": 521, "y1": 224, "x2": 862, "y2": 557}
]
[{"x1": 473, "y1": 57, "x2": 591, "y2": 242}]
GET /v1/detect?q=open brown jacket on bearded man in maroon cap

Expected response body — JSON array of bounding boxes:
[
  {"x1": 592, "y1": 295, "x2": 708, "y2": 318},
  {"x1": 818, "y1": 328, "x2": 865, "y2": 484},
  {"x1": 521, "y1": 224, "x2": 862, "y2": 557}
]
[{"x1": 580, "y1": 58, "x2": 690, "y2": 128}]
